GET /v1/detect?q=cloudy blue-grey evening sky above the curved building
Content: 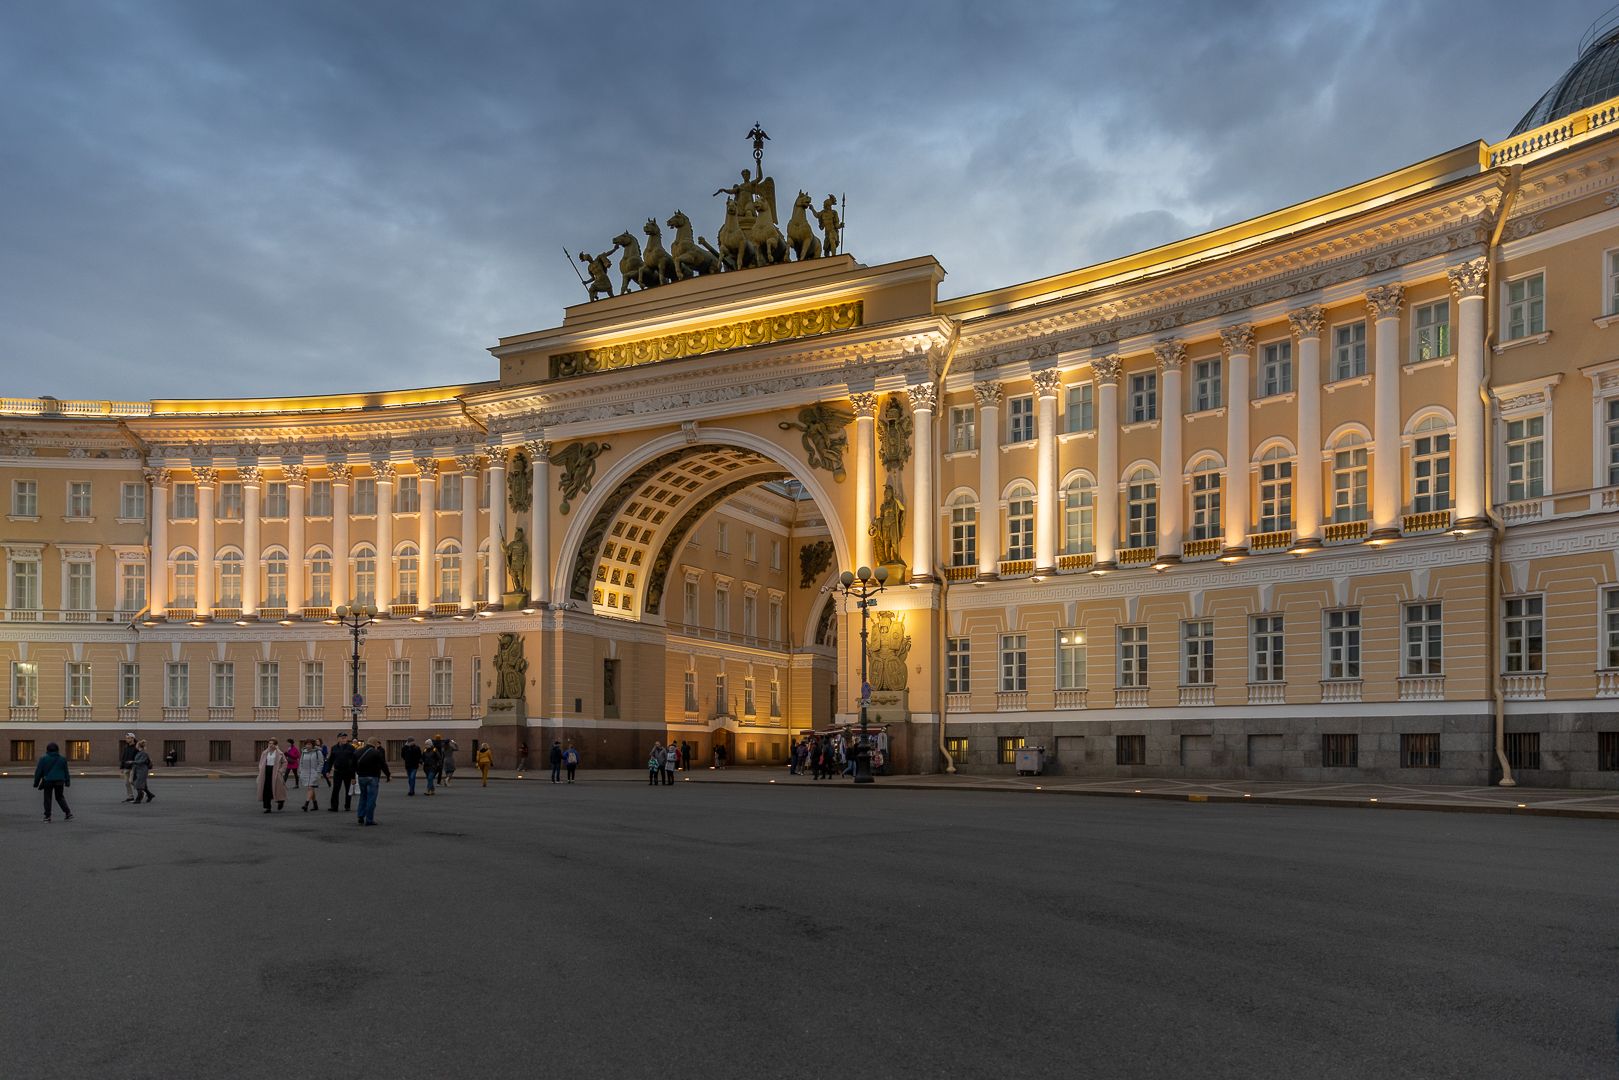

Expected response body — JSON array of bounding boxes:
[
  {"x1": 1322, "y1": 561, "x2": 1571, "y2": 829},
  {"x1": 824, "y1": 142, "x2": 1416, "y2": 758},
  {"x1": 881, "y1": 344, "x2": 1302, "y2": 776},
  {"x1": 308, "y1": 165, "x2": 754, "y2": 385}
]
[{"x1": 0, "y1": 0, "x2": 1606, "y2": 400}]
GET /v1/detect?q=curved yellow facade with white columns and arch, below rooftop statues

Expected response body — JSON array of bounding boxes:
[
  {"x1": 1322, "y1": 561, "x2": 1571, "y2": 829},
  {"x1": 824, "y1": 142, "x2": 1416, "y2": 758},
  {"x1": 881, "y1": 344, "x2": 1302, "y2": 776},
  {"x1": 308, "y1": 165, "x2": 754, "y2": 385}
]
[{"x1": 9, "y1": 59, "x2": 1619, "y2": 787}]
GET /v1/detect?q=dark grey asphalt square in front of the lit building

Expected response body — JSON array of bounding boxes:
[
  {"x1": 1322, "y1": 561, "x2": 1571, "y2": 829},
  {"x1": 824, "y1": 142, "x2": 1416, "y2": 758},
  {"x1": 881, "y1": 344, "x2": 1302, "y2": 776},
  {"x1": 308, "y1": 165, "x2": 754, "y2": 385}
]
[{"x1": 0, "y1": 774, "x2": 1619, "y2": 1080}]
